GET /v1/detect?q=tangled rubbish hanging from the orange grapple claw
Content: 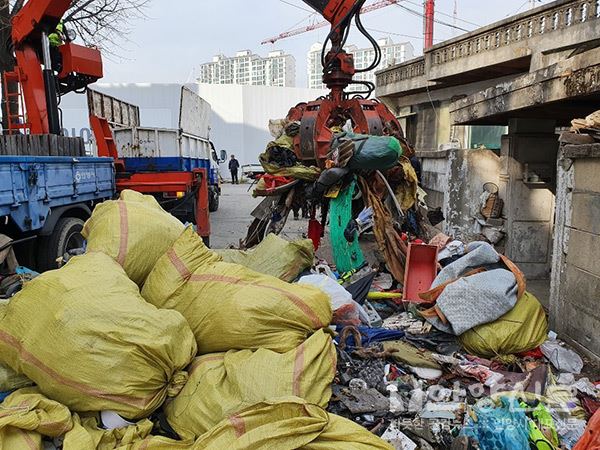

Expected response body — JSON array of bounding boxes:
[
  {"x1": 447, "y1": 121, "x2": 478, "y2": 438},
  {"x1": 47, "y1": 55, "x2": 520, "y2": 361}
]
[{"x1": 241, "y1": 120, "x2": 422, "y2": 268}]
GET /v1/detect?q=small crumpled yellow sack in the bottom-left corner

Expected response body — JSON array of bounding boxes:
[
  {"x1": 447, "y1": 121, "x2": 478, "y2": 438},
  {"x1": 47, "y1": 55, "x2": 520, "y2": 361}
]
[{"x1": 0, "y1": 388, "x2": 73, "y2": 450}]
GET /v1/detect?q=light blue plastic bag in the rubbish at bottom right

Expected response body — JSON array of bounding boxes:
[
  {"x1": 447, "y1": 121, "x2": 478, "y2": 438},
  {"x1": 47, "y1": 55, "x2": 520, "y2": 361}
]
[{"x1": 461, "y1": 397, "x2": 529, "y2": 450}]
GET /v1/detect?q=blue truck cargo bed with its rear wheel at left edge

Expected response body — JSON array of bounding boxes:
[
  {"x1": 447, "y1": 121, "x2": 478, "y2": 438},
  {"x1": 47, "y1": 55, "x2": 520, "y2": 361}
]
[{"x1": 0, "y1": 155, "x2": 115, "y2": 271}]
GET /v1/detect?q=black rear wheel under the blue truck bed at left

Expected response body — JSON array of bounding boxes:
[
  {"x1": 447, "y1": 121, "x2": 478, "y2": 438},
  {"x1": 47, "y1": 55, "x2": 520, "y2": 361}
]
[{"x1": 38, "y1": 217, "x2": 84, "y2": 271}]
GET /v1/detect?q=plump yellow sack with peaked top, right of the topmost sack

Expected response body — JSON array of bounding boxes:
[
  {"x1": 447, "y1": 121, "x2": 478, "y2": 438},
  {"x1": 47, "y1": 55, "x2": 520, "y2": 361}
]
[{"x1": 142, "y1": 228, "x2": 332, "y2": 354}]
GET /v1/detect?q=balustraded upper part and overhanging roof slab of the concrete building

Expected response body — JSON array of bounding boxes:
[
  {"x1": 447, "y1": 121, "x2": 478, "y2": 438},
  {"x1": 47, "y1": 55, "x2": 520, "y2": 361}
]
[{"x1": 377, "y1": 0, "x2": 600, "y2": 151}]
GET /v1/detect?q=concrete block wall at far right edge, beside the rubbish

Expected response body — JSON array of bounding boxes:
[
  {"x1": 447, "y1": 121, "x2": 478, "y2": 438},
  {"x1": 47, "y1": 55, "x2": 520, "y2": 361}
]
[{"x1": 550, "y1": 144, "x2": 600, "y2": 360}]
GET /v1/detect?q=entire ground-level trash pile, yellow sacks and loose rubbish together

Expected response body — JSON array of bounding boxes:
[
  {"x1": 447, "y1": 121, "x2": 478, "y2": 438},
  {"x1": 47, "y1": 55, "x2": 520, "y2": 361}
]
[{"x1": 0, "y1": 191, "x2": 600, "y2": 450}]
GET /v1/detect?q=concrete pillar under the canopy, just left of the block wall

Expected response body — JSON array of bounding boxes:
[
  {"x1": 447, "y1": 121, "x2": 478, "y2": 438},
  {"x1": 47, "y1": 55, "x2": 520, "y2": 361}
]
[{"x1": 500, "y1": 119, "x2": 558, "y2": 280}]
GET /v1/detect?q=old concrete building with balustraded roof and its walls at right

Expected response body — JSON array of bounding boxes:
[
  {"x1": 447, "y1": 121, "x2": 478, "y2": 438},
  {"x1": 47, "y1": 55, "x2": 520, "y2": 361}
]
[{"x1": 377, "y1": 0, "x2": 600, "y2": 361}]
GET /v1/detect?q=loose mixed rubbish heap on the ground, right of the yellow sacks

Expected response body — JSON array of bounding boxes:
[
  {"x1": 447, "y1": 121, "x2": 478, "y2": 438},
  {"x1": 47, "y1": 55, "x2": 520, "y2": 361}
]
[{"x1": 310, "y1": 236, "x2": 600, "y2": 450}]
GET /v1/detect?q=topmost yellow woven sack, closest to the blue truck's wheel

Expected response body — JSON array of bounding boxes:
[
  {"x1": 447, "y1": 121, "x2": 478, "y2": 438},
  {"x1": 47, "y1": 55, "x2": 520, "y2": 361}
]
[{"x1": 82, "y1": 191, "x2": 184, "y2": 286}]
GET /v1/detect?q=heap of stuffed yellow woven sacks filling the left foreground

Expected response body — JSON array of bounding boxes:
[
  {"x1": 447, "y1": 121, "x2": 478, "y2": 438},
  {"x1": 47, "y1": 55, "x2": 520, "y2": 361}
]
[{"x1": 0, "y1": 191, "x2": 392, "y2": 450}]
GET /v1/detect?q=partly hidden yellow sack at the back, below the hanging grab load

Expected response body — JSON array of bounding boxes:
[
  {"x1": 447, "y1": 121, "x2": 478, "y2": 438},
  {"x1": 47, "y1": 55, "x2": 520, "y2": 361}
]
[{"x1": 214, "y1": 234, "x2": 315, "y2": 282}]
